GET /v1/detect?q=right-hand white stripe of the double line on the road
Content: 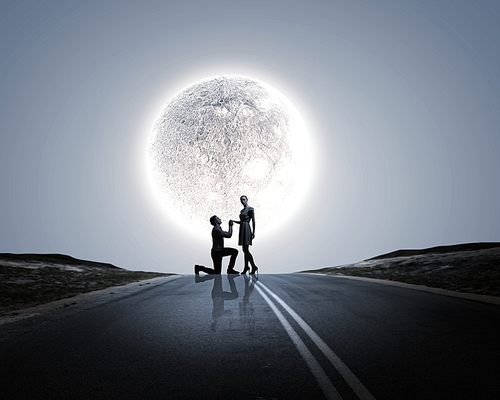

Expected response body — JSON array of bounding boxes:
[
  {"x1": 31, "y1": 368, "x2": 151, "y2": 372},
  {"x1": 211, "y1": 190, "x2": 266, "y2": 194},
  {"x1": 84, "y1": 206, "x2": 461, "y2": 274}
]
[{"x1": 256, "y1": 282, "x2": 375, "y2": 400}]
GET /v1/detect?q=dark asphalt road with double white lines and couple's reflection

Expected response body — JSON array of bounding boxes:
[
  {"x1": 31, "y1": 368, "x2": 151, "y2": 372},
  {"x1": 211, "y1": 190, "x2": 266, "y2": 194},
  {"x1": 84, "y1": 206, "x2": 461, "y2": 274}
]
[{"x1": 0, "y1": 274, "x2": 500, "y2": 400}]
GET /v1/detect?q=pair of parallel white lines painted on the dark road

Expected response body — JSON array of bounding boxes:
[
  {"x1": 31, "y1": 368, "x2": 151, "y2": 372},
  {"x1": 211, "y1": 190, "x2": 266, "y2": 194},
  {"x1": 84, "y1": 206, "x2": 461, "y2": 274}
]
[{"x1": 255, "y1": 282, "x2": 375, "y2": 400}]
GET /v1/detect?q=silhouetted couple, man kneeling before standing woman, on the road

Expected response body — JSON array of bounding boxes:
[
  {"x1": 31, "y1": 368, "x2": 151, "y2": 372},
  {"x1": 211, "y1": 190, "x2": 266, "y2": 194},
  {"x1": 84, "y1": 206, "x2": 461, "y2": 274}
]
[{"x1": 194, "y1": 196, "x2": 258, "y2": 275}]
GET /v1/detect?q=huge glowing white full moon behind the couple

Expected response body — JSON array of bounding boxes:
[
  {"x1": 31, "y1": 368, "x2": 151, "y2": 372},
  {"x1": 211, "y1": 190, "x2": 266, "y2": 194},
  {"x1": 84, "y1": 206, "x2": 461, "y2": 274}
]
[{"x1": 149, "y1": 76, "x2": 310, "y2": 229}]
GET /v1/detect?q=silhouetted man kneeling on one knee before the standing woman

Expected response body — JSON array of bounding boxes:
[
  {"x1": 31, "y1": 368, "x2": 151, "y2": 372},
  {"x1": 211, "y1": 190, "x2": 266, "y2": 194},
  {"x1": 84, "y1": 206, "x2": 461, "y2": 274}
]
[{"x1": 194, "y1": 215, "x2": 239, "y2": 275}]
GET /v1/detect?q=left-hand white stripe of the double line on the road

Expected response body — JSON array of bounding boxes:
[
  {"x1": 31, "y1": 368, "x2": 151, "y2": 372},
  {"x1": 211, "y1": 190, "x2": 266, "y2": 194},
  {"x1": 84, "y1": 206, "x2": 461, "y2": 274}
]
[{"x1": 255, "y1": 286, "x2": 342, "y2": 400}]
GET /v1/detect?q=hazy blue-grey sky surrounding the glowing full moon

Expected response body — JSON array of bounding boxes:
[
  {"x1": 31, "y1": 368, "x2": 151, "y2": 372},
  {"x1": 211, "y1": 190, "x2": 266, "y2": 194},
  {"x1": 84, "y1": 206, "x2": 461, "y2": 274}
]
[{"x1": 0, "y1": 0, "x2": 500, "y2": 273}]
